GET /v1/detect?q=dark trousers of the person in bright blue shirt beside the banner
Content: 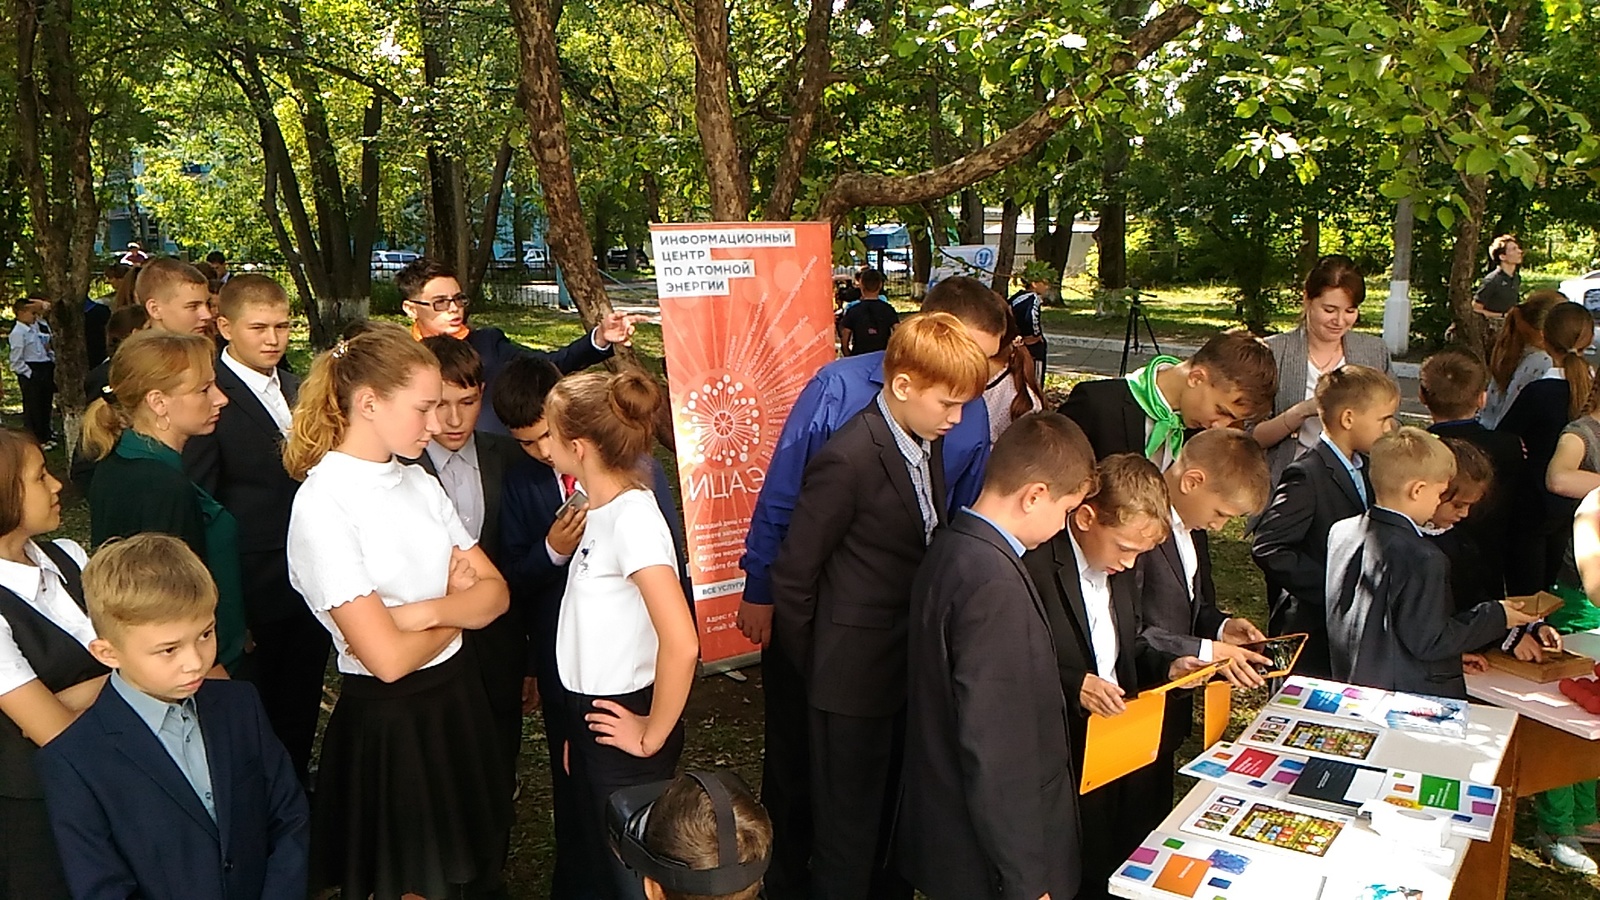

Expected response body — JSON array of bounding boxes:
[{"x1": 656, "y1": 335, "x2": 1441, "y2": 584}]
[{"x1": 762, "y1": 637, "x2": 811, "y2": 900}]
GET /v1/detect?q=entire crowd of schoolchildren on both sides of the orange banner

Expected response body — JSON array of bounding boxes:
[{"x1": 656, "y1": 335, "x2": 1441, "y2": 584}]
[{"x1": 0, "y1": 243, "x2": 1600, "y2": 900}]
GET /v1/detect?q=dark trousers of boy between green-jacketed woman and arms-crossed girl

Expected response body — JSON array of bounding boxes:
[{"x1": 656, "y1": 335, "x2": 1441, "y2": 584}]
[{"x1": 238, "y1": 549, "x2": 333, "y2": 785}]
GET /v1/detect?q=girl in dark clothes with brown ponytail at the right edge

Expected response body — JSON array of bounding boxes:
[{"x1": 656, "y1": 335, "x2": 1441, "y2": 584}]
[{"x1": 1494, "y1": 301, "x2": 1595, "y2": 594}]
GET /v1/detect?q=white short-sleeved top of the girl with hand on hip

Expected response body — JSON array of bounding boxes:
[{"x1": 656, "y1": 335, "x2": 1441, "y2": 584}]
[{"x1": 555, "y1": 488, "x2": 678, "y2": 697}]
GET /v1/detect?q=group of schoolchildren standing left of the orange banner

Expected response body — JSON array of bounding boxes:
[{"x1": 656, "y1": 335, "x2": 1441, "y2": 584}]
[{"x1": 0, "y1": 253, "x2": 771, "y2": 900}]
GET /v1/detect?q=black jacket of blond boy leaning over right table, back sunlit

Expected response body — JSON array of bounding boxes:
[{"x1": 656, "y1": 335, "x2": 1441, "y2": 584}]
[{"x1": 1326, "y1": 508, "x2": 1506, "y2": 700}]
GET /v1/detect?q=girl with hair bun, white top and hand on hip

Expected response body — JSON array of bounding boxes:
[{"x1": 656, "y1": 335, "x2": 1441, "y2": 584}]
[{"x1": 544, "y1": 372, "x2": 699, "y2": 900}]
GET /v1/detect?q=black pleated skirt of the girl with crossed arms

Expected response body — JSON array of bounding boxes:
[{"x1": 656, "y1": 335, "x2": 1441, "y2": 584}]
[{"x1": 310, "y1": 649, "x2": 512, "y2": 900}]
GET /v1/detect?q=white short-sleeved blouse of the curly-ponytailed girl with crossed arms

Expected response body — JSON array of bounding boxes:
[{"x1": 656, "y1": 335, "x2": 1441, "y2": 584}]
[{"x1": 288, "y1": 452, "x2": 477, "y2": 676}]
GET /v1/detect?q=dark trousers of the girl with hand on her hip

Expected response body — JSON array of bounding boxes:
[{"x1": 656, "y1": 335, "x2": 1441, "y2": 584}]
[{"x1": 566, "y1": 685, "x2": 683, "y2": 900}]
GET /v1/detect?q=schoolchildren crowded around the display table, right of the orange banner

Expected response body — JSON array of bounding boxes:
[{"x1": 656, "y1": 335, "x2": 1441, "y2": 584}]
[{"x1": 739, "y1": 279, "x2": 1600, "y2": 900}]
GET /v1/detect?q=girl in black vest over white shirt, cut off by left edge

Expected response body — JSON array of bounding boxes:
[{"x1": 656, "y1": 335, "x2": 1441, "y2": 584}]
[{"x1": 0, "y1": 431, "x2": 107, "y2": 900}]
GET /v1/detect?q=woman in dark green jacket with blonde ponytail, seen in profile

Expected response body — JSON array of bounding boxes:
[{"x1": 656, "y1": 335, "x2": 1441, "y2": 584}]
[{"x1": 83, "y1": 331, "x2": 245, "y2": 671}]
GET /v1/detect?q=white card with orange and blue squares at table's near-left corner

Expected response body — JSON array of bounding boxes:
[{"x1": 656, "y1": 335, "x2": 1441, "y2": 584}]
[{"x1": 1110, "y1": 831, "x2": 1323, "y2": 900}]
